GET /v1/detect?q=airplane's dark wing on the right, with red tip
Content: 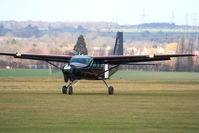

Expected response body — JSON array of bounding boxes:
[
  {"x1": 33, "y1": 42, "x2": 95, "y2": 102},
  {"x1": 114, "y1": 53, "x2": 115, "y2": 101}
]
[{"x1": 93, "y1": 54, "x2": 197, "y2": 65}]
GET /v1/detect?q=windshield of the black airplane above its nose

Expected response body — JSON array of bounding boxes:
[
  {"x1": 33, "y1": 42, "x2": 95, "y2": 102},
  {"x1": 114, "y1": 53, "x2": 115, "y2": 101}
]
[{"x1": 70, "y1": 56, "x2": 93, "y2": 65}]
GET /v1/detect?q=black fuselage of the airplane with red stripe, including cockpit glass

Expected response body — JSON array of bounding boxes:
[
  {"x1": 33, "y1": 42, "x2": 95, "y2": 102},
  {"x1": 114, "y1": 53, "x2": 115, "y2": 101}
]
[{"x1": 62, "y1": 55, "x2": 118, "y2": 82}]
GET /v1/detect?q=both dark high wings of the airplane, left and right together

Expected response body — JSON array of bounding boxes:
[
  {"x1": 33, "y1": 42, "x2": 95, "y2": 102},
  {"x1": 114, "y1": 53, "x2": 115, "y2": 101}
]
[{"x1": 0, "y1": 53, "x2": 197, "y2": 65}]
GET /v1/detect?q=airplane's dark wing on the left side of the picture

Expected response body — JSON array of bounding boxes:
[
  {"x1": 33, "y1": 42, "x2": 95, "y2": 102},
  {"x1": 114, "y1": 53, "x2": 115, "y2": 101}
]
[{"x1": 0, "y1": 53, "x2": 72, "y2": 63}]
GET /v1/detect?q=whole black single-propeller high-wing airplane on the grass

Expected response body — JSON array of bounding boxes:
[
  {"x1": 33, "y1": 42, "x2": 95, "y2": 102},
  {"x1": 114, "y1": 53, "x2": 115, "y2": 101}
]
[{"x1": 0, "y1": 32, "x2": 197, "y2": 95}]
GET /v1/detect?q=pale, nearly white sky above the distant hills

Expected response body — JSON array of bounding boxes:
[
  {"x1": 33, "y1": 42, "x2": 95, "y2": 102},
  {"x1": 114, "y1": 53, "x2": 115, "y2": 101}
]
[{"x1": 0, "y1": 0, "x2": 199, "y2": 26}]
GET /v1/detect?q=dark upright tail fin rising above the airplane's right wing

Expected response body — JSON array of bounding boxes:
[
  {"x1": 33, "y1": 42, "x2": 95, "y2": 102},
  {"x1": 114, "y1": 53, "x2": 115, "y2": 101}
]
[{"x1": 113, "y1": 32, "x2": 123, "y2": 55}]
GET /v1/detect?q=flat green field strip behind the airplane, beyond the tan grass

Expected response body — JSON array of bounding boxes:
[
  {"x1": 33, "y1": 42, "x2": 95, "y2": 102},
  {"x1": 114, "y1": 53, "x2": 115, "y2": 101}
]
[{"x1": 0, "y1": 69, "x2": 199, "y2": 79}]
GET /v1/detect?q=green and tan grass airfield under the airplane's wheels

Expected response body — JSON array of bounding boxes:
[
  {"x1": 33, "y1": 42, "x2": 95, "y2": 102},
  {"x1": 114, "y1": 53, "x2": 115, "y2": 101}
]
[{"x1": 0, "y1": 70, "x2": 199, "y2": 133}]
